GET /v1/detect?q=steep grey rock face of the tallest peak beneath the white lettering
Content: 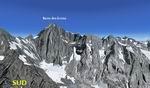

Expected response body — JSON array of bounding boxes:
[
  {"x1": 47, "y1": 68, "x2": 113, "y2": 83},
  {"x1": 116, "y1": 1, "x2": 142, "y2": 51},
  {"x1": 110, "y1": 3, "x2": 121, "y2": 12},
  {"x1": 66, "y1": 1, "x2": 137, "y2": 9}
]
[{"x1": 35, "y1": 26, "x2": 74, "y2": 65}]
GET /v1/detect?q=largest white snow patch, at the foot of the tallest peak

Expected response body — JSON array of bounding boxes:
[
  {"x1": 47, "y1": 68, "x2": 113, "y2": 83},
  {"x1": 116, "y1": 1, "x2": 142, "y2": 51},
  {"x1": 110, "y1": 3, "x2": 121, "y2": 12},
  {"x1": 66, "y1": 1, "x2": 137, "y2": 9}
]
[{"x1": 40, "y1": 61, "x2": 66, "y2": 83}]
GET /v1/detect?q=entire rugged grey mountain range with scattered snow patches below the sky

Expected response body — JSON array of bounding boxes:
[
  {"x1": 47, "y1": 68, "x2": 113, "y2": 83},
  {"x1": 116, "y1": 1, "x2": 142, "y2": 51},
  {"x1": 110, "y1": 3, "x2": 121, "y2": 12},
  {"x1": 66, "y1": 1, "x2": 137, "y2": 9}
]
[{"x1": 0, "y1": 24, "x2": 150, "y2": 88}]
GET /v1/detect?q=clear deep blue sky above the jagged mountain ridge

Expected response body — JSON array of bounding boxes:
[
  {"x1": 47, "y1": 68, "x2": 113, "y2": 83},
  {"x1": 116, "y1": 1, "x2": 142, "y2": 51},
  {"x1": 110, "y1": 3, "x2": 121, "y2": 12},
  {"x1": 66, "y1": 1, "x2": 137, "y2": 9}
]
[{"x1": 0, "y1": 0, "x2": 150, "y2": 39}]
